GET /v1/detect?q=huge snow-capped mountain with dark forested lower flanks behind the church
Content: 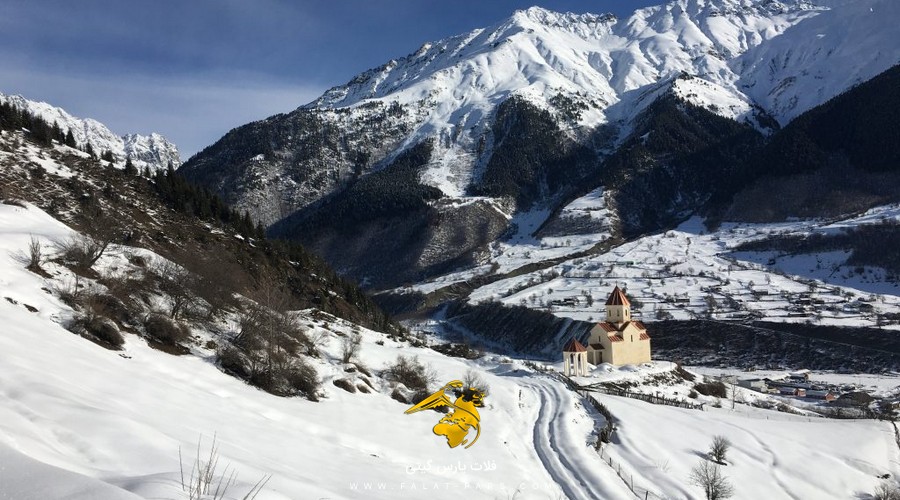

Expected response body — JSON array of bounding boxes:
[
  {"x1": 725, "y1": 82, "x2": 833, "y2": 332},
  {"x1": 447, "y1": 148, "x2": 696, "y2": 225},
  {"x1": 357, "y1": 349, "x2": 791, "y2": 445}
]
[{"x1": 181, "y1": 0, "x2": 900, "y2": 290}]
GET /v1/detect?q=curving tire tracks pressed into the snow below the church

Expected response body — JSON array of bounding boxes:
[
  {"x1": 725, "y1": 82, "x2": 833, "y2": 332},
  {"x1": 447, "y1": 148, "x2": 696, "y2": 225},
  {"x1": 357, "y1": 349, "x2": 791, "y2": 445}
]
[{"x1": 525, "y1": 378, "x2": 636, "y2": 500}]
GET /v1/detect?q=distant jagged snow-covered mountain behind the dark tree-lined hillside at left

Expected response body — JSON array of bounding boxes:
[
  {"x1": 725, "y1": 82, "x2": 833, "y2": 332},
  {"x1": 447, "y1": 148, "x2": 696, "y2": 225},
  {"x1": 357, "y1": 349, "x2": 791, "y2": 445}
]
[{"x1": 0, "y1": 93, "x2": 181, "y2": 170}]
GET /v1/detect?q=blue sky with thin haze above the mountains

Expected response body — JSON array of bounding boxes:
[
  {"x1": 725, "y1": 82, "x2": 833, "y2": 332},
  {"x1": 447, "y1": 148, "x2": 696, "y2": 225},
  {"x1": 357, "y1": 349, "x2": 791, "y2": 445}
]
[{"x1": 0, "y1": 0, "x2": 663, "y2": 159}]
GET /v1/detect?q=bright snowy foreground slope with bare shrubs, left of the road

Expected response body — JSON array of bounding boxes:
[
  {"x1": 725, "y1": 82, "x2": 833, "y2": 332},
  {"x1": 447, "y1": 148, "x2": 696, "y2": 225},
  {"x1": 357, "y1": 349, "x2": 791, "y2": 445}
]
[{"x1": 0, "y1": 205, "x2": 632, "y2": 500}]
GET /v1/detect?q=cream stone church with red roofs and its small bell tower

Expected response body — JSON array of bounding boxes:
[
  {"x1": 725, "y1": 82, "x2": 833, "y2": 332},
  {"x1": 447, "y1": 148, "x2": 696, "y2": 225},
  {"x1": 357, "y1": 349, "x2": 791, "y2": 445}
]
[{"x1": 563, "y1": 286, "x2": 650, "y2": 375}]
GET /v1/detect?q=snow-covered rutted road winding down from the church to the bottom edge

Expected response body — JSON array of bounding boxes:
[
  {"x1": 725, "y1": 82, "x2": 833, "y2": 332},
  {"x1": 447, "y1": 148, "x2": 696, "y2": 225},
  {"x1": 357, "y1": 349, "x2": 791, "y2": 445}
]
[{"x1": 522, "y1": 378, "x2": 636, "y2": 500}]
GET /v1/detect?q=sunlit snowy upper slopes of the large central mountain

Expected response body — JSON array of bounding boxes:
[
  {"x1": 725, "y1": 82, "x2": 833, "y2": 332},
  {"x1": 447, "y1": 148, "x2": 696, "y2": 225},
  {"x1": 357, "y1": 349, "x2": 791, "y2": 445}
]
[{"x1": 306, "y1": 0, "x2": 900, "y2": 196}]
